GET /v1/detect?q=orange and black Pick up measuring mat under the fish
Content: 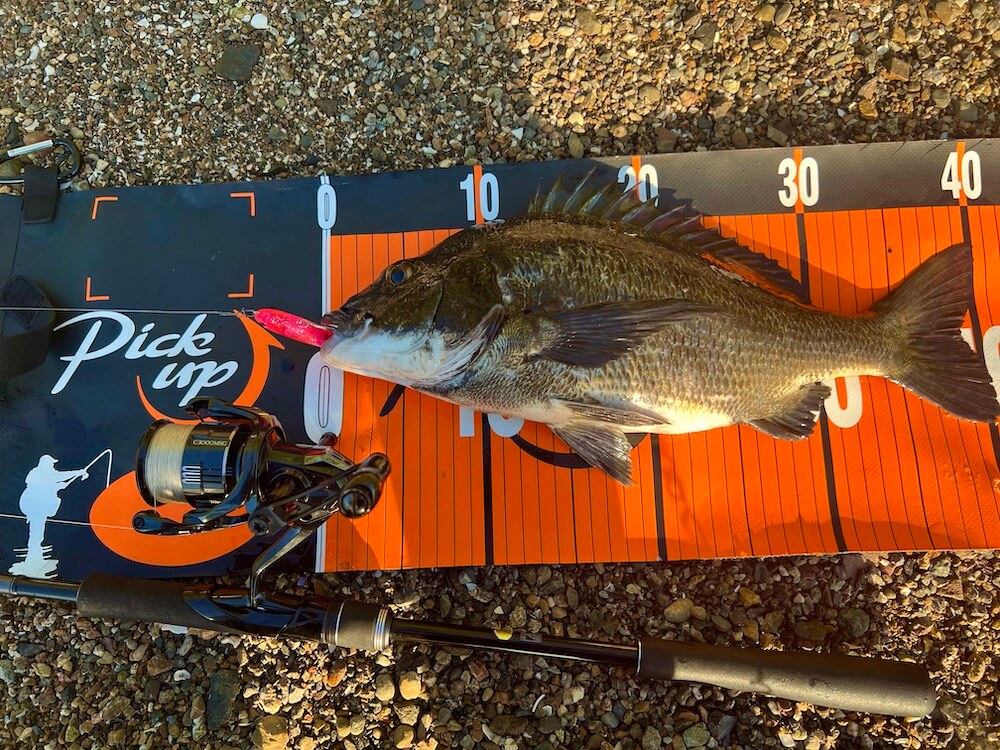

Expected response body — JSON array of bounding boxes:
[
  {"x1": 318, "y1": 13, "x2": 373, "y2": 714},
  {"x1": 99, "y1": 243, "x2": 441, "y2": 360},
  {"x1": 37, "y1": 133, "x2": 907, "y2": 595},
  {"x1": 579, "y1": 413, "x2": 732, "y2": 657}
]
[{"x1": 0, "y1": 140, "x2": 1000, "y2": 579}]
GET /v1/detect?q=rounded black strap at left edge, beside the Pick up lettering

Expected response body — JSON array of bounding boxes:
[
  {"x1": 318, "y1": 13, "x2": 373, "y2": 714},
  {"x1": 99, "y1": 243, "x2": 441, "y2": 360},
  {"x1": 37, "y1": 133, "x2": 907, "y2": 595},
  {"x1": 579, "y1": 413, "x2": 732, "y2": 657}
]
[{"x1": 0, "y1": 276, "x2": 56, "y2": 381}]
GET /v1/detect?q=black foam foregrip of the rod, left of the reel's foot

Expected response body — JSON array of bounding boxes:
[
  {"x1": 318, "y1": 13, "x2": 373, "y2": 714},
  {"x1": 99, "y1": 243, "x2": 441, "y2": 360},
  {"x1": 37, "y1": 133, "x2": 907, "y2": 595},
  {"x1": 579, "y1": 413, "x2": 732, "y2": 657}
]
[{"x1": 76, "y1": 573, "x2": 240, "y2": 633}]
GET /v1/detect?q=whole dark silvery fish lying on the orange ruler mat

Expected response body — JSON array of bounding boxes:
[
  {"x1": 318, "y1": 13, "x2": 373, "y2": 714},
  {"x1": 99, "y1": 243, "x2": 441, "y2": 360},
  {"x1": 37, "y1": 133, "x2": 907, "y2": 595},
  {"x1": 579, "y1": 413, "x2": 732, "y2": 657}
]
[{"x1": 321, "y1": 173, "x2": 1000, "y2": 485}]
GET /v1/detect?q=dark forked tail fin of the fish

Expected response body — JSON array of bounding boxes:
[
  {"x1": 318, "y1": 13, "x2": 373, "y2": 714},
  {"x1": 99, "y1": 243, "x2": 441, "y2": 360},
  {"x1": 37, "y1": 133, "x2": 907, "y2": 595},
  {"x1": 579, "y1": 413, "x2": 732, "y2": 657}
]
[{"x1": 872, "y1": 244, "x2": 1000, "y2": 422}]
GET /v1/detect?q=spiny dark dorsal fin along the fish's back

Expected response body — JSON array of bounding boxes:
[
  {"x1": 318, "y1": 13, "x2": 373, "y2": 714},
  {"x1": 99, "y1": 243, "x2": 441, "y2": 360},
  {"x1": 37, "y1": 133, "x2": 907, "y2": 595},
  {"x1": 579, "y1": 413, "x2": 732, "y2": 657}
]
[{"x1": 528, "y1": 170, "x2": 808, "y2": 303}]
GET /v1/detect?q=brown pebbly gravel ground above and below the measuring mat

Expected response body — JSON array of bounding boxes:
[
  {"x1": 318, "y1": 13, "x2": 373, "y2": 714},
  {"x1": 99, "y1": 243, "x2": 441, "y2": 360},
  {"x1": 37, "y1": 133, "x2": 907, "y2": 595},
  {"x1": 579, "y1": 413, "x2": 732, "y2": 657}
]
[{"x1": 0, "y1": 0, "x2": 1000, "y2": 750}]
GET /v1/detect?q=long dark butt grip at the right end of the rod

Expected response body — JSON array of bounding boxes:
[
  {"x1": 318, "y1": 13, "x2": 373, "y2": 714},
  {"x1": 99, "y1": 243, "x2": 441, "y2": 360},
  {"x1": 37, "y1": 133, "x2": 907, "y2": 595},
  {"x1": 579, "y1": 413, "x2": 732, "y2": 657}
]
[{"x1": 637, "y1": 638, "x2": 936, "y2": 717}]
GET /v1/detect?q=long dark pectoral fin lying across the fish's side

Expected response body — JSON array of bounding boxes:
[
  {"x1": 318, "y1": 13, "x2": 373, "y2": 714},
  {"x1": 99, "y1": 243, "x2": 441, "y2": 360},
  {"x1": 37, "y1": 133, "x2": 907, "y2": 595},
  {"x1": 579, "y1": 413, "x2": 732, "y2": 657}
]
[{"x1": 525, "y1": 299, "x2": 723, "y2": 367}]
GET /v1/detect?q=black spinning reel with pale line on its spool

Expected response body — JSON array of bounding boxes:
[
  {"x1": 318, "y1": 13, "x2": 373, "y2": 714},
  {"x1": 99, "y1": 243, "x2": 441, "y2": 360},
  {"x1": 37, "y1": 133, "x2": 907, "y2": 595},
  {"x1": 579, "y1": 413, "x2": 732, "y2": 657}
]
[{"x1": 132, "y1": 399, "x2": 390, "y2": 596}]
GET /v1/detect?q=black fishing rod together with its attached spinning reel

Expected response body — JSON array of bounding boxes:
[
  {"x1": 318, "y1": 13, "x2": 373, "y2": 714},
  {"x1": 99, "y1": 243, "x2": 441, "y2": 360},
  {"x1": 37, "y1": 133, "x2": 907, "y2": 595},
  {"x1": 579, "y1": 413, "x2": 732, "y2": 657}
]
[{"x1": 0, "y1": 399, "x2": 936, "y2": 717}]
